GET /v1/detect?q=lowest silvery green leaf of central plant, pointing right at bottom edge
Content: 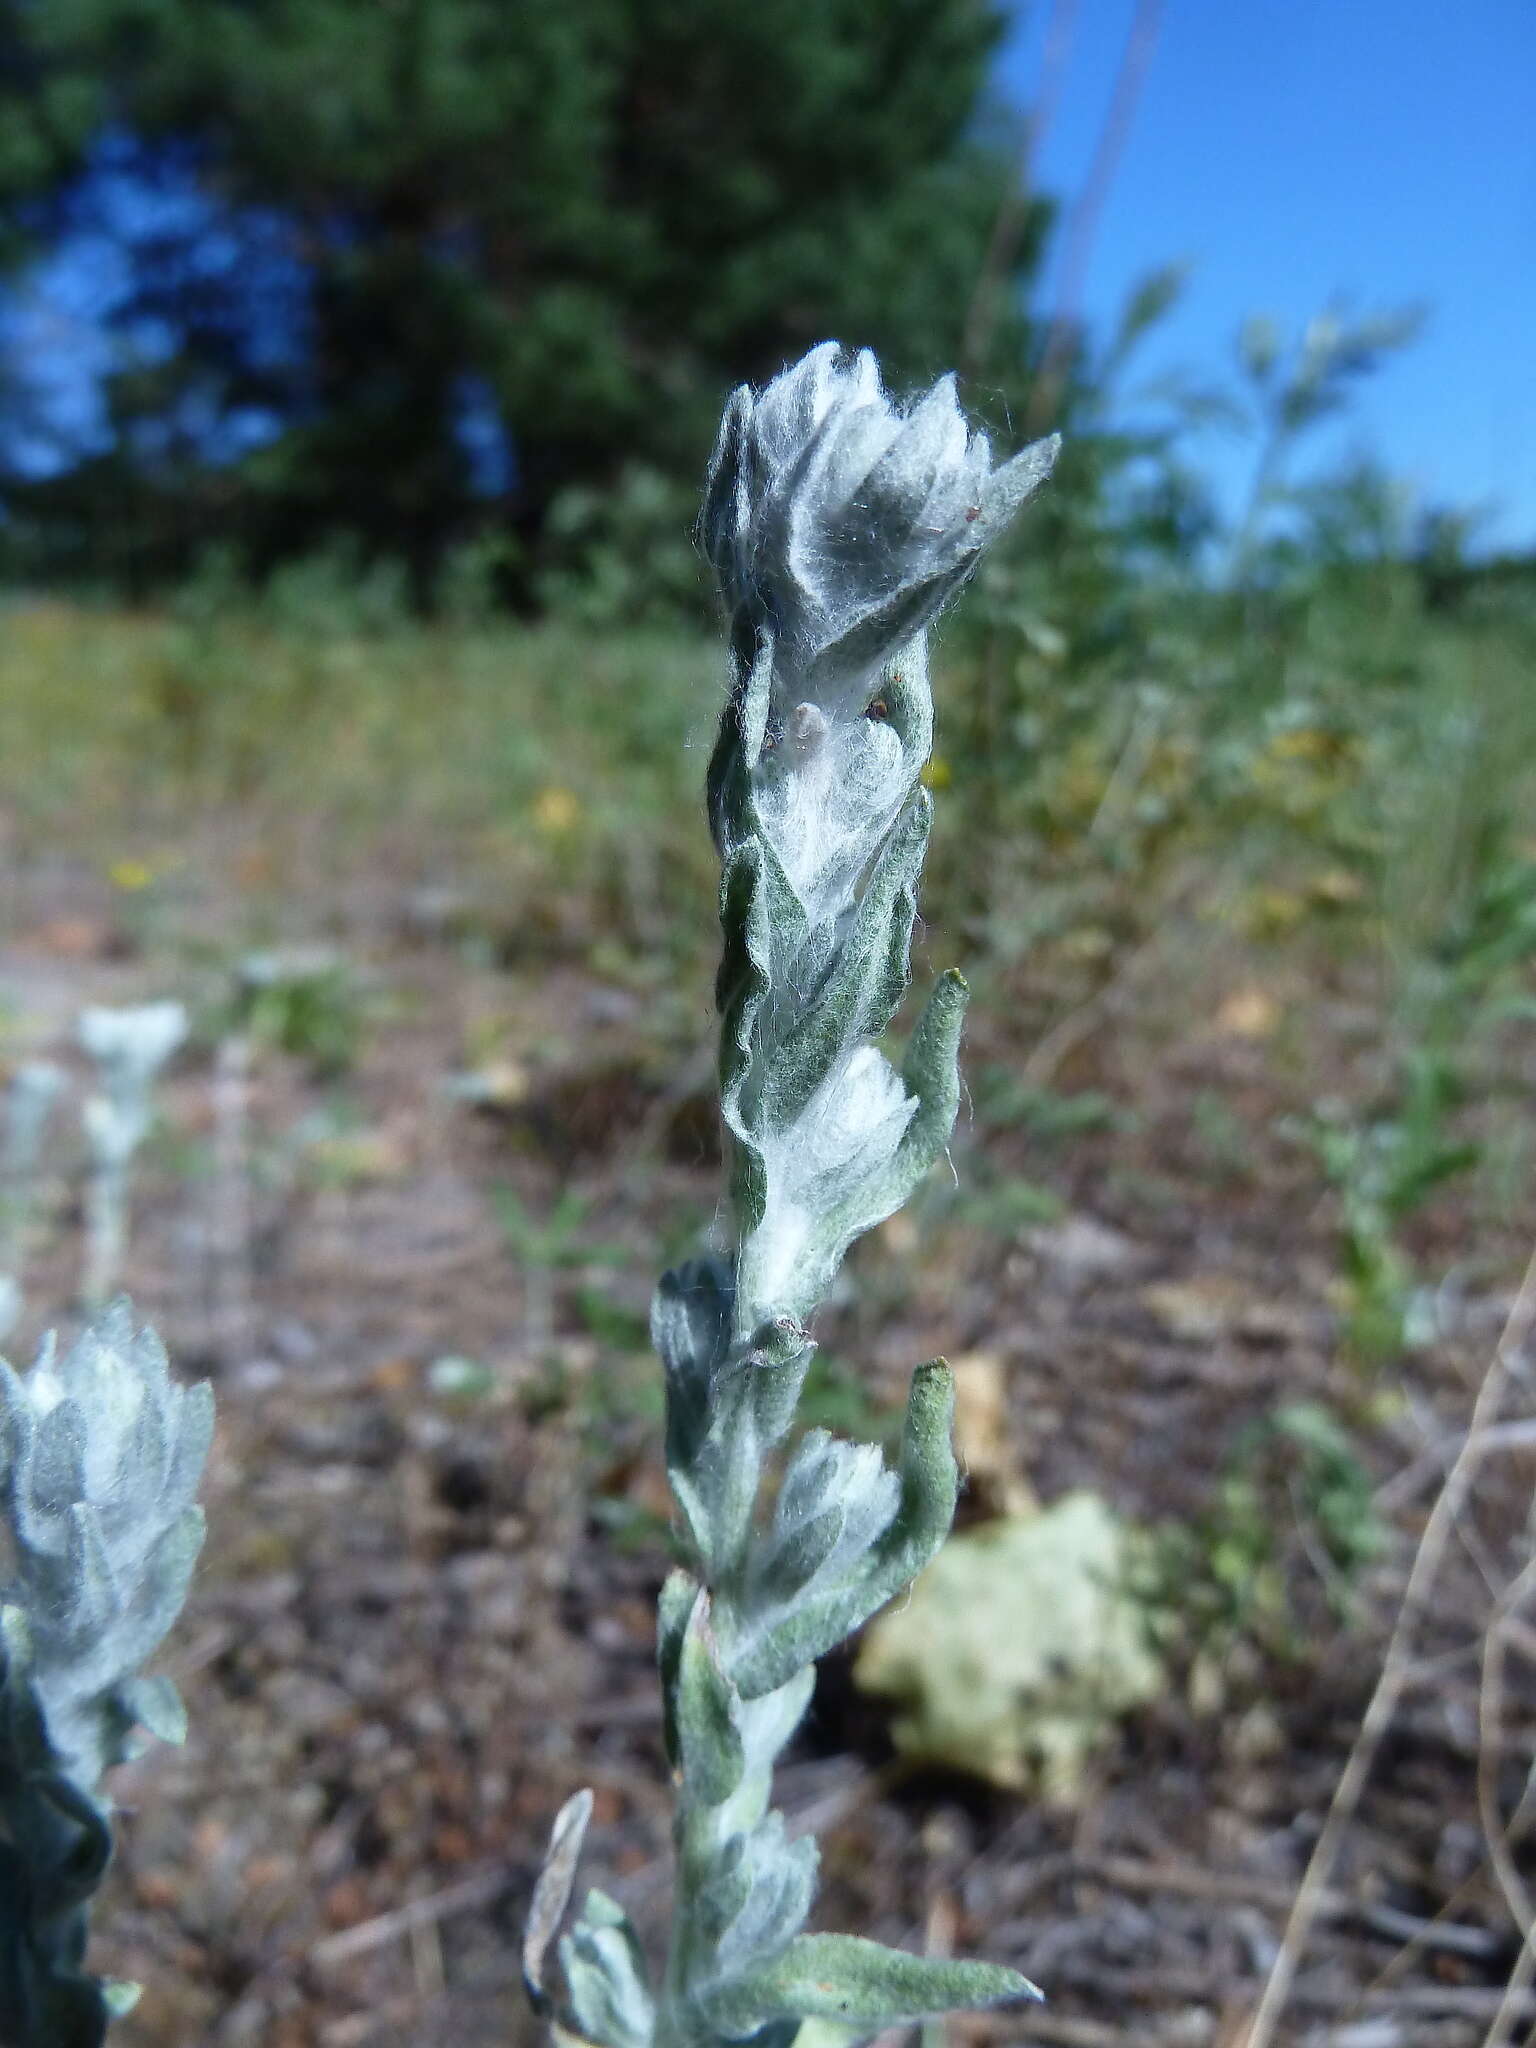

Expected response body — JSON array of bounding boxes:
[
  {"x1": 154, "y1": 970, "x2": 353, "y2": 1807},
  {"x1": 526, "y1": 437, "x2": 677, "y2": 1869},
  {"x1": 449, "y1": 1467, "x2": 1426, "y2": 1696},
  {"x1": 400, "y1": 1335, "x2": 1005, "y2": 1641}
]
[{"x1": 711, "y1": 1933, "x2": 1040, "y2": 2040}]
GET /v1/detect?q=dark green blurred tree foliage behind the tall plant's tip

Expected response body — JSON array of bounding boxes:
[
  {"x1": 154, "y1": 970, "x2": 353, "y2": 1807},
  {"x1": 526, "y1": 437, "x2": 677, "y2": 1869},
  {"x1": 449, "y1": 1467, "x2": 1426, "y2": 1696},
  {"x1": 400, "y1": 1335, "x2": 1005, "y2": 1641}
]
[{"x1": 0, "y1": 0, "x2": 1038, "y2": 594}]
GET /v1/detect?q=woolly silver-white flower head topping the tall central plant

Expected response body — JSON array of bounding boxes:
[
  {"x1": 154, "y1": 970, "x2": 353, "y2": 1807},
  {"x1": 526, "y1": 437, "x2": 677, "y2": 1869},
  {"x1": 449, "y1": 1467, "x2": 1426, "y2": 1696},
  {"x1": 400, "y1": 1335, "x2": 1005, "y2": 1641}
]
[{"x1": 700, "y1": 342, "x2": 1059, "y2": 937}]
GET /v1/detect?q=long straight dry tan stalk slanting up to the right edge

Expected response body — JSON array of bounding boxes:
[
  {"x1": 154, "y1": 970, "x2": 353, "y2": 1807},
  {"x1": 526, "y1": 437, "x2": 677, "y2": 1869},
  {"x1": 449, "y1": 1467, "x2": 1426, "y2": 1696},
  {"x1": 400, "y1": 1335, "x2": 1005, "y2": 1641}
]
[{"x1": 1245, "y1": 1249, "x2": 1536, "y2": 2048}]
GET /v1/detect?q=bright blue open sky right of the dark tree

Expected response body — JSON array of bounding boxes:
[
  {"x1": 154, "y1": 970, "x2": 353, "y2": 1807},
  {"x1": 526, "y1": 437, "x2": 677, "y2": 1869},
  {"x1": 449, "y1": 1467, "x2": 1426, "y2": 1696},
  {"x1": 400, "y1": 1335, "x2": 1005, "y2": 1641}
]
[{"x1": 999, "y1": 0, "x2": 1536, "y2": 547}]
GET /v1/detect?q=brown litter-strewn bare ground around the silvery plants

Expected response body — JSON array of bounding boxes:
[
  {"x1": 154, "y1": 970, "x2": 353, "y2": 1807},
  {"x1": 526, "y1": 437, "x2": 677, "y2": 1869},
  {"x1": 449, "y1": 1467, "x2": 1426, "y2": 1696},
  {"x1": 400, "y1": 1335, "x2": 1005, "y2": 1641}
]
[{"x1": 0, "y1": 835, "x2": 1536, "y2": 2048}]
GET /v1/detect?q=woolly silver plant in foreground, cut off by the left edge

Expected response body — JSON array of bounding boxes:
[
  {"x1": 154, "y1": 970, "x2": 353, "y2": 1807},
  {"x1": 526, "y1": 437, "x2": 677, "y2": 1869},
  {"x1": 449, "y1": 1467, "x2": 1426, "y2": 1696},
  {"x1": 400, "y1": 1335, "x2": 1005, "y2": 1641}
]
[{"x1": 0, "y1": 1303, "x2": 213, "y2": 2048}]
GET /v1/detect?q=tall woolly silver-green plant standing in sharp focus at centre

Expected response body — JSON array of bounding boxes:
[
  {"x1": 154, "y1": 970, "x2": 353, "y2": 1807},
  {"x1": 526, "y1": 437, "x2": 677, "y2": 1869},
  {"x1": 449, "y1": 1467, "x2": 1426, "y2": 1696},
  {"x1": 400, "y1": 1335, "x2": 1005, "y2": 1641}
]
[{"x1": 524, "y1": 344, "x2": 1057, "y2": 2048}]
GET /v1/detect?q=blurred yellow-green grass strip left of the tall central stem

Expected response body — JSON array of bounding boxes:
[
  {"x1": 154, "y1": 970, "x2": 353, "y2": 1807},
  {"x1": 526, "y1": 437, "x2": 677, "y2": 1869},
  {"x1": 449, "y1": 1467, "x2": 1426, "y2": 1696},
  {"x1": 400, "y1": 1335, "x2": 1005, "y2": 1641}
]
[{"x1": 0, "y1": 600, "x2": 723, "y2": 938}]
